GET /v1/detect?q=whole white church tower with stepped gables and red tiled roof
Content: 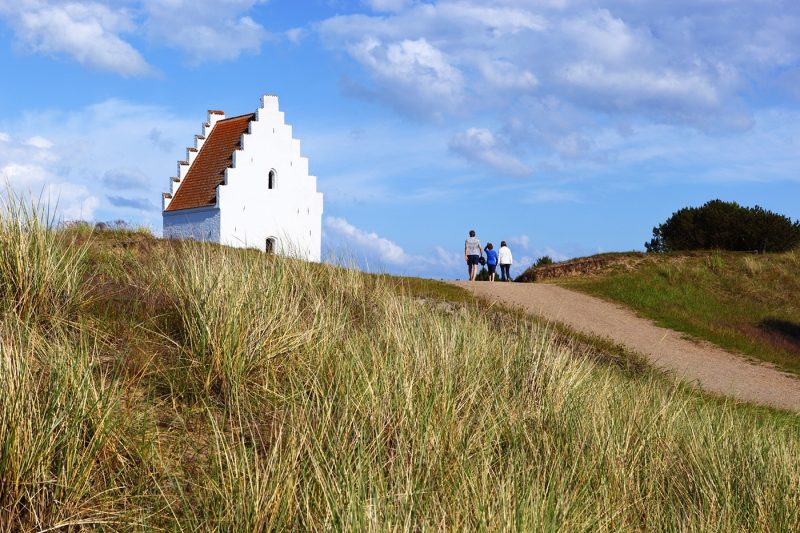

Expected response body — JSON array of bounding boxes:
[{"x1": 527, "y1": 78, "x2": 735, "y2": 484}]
[{"x1": 162, "y1": 95, "x2": 322, "y2": 261}]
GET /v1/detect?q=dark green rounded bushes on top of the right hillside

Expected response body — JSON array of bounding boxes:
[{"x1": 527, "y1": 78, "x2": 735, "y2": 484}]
[{"x1": 644, "y1": 200, "x2": 800, "y2": 253}]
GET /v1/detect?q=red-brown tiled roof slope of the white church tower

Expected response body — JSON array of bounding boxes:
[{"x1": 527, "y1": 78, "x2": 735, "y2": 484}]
[{"x1": 166, "y1": 113, "x2": 256, "y2": 211}]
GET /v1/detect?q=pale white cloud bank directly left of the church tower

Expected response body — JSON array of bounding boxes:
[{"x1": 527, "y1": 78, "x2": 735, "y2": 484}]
[{"x1": 0, "y1": 100, "x2": 197, "y2": 223}]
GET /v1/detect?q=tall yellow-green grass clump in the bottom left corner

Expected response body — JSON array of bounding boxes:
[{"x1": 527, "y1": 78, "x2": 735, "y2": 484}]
[{"x1": 0, "y1": 320, "x2": 135, "y2": 531}]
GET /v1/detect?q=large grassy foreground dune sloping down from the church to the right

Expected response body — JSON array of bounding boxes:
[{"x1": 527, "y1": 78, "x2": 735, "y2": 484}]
[{"x1": 0, "y1": 201, "x2": 800, "y2": 531}]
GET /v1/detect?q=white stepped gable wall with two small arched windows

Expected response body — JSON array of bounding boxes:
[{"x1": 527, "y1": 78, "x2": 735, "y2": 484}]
[{"x1": 217, "y1": 95, "x2": 323, "y2": 261}]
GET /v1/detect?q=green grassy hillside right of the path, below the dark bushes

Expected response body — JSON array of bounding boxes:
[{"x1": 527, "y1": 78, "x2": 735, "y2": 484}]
[{"x1": 520, "y1": 252, "x2": 800, "y2": 373}]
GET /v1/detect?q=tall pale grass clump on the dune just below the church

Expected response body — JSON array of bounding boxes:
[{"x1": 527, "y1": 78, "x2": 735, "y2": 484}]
[{"x1": 158, "y1": 245, "x2": 324, "y2": 403}]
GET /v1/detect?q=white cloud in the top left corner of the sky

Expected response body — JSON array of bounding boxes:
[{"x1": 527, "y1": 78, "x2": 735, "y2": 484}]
[{"x1": 0, "y1": 0, "x2": 153, "y2": 76}]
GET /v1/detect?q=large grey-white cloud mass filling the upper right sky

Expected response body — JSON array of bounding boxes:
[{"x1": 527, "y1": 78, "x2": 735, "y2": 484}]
[{"x1": 315, "y1": 0, "x2": 800, "y2": 152}]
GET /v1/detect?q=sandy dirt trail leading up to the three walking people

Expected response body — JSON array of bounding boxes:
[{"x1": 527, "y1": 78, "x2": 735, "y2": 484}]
[{"x1": 454, "y1": 281, "x2": 800, "y2": 411}]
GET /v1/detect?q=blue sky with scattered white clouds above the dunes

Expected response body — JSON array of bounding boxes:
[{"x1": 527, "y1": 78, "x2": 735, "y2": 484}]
[{"x1": 0, "y1": 0, "x2": 800, "y2": 278}]
